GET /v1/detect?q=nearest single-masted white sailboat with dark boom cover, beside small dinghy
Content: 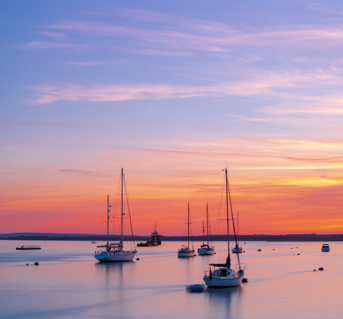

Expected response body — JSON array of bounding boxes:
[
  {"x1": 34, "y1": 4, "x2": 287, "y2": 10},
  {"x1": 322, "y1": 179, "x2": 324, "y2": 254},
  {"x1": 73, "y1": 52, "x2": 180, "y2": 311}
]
[{"x1": 203, "y1": 168, "x2": 245, "y2": 287}]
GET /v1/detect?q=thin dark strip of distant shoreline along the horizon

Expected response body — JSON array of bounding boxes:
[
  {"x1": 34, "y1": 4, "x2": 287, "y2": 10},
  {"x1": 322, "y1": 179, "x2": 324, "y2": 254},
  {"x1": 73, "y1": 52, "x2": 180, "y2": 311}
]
[{"x1": 0, "y1": 233, "x2": 343, "y2": 242}]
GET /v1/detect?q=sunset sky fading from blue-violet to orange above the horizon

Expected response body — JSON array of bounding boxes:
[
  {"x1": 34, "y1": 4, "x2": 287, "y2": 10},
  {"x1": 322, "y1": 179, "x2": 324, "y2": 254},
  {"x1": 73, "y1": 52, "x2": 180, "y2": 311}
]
[{"x1": 0, "y1": 0, "x2": 343, "y2": 235}]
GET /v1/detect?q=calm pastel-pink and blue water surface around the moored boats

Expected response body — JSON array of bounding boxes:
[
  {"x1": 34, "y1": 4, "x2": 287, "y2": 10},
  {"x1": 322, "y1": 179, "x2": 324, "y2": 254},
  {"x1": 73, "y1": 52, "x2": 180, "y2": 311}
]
[{"x1": 0, "y1": 241, "x2": 343, "y2": 319}]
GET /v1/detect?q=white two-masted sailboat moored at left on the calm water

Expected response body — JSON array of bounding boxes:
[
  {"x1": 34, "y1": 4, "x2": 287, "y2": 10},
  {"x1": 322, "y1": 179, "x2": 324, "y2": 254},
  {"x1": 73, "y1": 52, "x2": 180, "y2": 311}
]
[{"x1": 94, "y1": 168, "x2": 137, "y2": 262}]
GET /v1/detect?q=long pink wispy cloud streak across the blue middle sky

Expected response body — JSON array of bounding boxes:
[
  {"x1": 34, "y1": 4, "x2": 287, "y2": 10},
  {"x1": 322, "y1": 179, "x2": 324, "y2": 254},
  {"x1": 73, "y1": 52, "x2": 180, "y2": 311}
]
[{"x1": 29, "y1": 68, "x2": 343, "y2": 104}]
